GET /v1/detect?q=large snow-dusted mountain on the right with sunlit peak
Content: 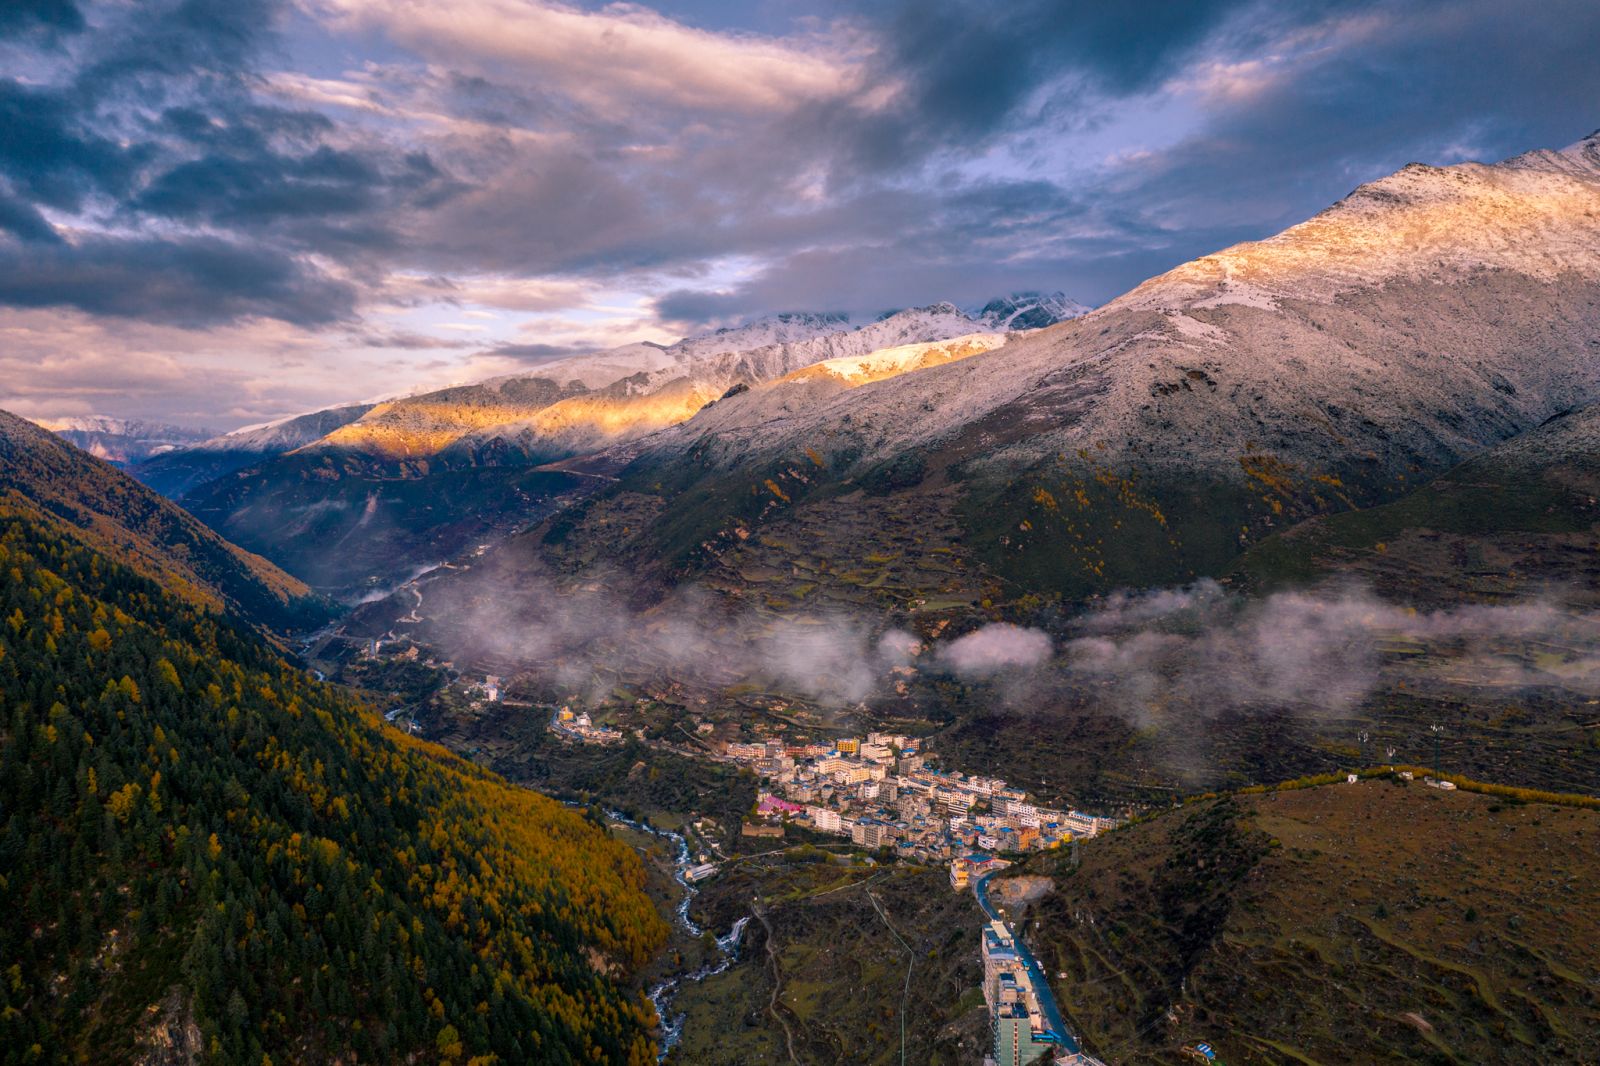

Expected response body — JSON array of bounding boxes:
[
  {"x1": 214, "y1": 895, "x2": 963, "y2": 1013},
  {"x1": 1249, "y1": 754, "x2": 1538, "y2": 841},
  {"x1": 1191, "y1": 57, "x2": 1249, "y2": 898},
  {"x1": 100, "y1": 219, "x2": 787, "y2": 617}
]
[{"x1": 508, "y1": 134, "x2": 1600, "y2": 594}]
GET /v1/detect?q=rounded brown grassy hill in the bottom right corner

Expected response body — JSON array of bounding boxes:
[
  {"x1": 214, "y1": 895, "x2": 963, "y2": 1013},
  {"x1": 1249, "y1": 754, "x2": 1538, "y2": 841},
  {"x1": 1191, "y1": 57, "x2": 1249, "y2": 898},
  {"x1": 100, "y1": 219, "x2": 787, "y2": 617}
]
[{"x1": 1004, "y1": 779, "x2": 1600, "y2": 1066}]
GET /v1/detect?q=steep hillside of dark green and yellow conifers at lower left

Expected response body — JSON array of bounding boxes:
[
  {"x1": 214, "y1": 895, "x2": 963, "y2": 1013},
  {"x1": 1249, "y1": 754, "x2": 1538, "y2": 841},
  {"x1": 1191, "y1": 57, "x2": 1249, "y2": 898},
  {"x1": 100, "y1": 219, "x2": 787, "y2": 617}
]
[{"x1": 0, "y1": 503, "x2": 666, "y2": 1066}]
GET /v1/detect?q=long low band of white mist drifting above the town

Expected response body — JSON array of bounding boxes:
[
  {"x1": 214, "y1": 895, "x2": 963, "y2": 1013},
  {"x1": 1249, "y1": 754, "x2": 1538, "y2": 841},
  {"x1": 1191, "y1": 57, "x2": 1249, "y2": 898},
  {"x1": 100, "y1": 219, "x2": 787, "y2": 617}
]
[{"x1": 425, "y1": 560, "x2": 1600, "y2": 727}]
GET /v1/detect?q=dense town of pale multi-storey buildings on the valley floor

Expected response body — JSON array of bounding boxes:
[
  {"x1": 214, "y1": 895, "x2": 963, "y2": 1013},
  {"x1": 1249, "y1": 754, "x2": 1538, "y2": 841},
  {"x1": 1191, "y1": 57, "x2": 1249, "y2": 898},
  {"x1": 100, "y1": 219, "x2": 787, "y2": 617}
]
[{"x1": 722, "y1": 733, "x2": 1117, "y2": 857}]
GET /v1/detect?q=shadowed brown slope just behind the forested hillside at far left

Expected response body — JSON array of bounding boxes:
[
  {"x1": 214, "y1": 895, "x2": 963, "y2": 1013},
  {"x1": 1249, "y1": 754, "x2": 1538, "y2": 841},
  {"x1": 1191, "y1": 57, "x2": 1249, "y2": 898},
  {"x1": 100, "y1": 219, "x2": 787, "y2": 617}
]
[{"x1": 0, "y1": 411, "x2": 325, "y2": 631}]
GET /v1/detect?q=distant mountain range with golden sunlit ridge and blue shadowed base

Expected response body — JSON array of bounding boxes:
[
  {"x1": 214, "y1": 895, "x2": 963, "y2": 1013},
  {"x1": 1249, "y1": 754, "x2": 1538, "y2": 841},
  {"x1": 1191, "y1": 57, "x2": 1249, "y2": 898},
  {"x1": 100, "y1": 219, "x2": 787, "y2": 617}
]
[{"x1": 133, "y1": 293, "x2": 1083, "y2": 597}]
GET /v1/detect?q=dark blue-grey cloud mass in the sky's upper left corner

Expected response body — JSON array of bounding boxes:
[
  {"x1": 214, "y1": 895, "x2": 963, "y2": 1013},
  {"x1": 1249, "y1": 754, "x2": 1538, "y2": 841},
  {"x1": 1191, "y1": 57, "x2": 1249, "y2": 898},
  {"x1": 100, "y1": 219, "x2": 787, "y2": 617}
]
[{"x1": 0, "y1": 0, "x2": 461, "y2": 327}]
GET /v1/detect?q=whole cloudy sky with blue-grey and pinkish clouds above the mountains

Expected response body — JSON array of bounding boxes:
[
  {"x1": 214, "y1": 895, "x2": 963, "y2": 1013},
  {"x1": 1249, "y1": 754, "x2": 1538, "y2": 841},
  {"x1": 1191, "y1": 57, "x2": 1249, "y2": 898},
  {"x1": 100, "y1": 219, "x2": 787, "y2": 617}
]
[{"x1": 0, "y1": 0, "x2": 1600, "y2": 429}]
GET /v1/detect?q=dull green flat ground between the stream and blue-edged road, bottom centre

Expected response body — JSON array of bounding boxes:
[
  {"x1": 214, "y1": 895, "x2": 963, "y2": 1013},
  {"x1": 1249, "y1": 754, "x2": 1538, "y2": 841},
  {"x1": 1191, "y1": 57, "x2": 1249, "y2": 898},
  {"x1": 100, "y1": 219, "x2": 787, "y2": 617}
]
[{"x1": 669, "y1": 856, "x2": 984, "y2": 1066}]
